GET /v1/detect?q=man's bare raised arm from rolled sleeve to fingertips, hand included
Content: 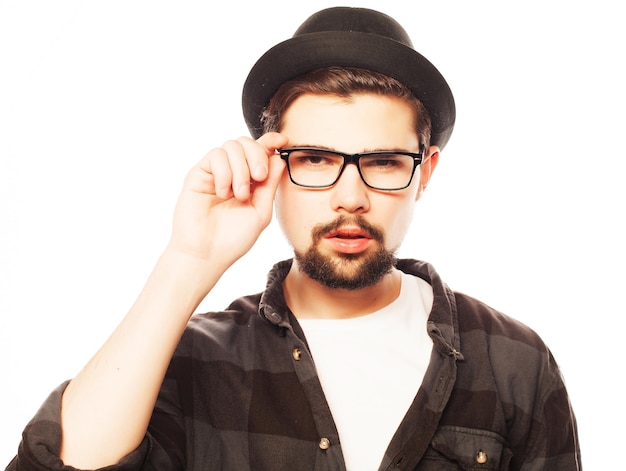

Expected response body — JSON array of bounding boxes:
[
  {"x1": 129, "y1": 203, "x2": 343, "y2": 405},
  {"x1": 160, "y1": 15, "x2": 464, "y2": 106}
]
[{"x1": 56, "y1": 133, "x2": 286, "y2": 469}]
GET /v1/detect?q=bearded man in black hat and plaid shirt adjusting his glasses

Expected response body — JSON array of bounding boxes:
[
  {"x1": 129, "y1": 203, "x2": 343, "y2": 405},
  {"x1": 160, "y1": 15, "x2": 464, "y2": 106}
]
[{"x1": 8, "y1": 8, "x2": 580, "y2": 471}]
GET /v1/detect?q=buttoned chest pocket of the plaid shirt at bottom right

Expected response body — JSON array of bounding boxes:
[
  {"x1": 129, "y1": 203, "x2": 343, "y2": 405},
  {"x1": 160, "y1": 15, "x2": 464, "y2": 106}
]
[{"x1": 415, "y1": 427, "x2": 511, "y2": 471}]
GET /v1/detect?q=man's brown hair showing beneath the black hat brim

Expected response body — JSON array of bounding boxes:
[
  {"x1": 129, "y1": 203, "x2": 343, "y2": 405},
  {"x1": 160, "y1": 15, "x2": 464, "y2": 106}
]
[{"x1": 261, "y1": 67, "x2": 431, "y2": 151}]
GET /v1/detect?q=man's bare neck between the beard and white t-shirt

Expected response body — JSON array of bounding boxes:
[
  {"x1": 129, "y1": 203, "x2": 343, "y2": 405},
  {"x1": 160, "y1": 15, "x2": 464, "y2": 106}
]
[{"x1": 283, "y1": 260, "x2": 402, "y2": 319}]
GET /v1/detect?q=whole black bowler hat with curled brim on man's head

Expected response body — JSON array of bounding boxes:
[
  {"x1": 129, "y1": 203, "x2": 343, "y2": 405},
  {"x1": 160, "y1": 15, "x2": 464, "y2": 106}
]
[{"x1": 242, "y1": 7, "x2": 456, "y2": 149}]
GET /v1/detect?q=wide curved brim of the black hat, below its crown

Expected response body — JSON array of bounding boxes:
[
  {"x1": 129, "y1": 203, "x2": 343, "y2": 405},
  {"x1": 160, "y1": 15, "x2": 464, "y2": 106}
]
[{"x1": 242, "y1": 31, "x2": 456, "y2": 149}]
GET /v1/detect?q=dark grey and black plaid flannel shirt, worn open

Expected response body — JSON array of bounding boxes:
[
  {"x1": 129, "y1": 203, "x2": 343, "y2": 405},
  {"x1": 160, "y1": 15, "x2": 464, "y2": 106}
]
[{"x1": 7, "y1": 260, "x2": 581, "y2": 471}]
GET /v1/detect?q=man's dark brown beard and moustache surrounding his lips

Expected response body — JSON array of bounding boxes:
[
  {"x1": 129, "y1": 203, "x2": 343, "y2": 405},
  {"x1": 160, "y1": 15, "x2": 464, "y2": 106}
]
[{"x1": 295, "y1": 216, "x2": 396, "y2": 291}]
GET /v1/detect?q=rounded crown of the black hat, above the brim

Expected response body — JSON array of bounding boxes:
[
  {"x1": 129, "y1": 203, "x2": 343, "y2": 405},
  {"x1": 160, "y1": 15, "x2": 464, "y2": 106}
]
[{"x1": 294, "y1": 7, "x2": 413, "y2": 49}]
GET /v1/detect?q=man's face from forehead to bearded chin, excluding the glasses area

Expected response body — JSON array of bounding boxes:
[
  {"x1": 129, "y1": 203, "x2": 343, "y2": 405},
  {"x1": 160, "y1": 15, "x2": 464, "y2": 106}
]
[{"x1": 276, "y1": 94, "x2": 436, "y2": 289}]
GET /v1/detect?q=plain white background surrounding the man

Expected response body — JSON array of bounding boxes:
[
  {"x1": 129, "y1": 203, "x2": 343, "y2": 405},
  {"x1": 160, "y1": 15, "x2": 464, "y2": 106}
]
[{"x1": 0, "y1": 0, "x2": 626, "y2": 470}]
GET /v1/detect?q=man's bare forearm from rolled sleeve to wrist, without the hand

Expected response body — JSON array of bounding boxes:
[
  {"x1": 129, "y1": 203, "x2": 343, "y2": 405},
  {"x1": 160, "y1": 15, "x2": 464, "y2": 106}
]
[{"x1": 61, "y1": 251, "x2": 222, "y2": 469}]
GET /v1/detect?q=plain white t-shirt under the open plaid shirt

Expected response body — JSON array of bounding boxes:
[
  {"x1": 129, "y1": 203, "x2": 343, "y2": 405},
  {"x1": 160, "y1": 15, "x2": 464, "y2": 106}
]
[{"x1": 298, "y1": 273, "x2": 433, "y2": 471}]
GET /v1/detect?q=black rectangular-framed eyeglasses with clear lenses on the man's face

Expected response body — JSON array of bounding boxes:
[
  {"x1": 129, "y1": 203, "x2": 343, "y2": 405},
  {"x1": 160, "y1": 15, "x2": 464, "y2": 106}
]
[{"x1": 278, "y1": 147, "x2": 423, "y2": 191}]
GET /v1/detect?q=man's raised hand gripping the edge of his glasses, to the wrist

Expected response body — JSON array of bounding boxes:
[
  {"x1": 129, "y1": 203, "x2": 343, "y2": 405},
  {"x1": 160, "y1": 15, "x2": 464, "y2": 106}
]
[{"x1": 168, "y1": 133, "x2": 287, "y2": 269}]
